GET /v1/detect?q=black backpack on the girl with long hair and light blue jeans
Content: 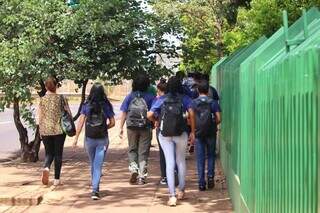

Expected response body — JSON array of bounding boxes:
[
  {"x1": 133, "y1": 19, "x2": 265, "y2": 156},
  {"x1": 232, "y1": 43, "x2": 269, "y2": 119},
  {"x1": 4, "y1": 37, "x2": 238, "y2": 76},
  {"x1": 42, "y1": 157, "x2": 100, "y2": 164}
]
[{"x1": 86, "y1": 105, "x2": 108, "y2": 139}]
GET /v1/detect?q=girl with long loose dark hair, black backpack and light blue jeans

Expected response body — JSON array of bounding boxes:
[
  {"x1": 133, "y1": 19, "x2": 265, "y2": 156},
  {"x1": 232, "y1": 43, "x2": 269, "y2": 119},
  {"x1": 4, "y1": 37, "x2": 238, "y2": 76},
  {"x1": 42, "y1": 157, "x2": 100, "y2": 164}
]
[{"x1": 73, "y1": 83, "x2": 115, "y2": 200}]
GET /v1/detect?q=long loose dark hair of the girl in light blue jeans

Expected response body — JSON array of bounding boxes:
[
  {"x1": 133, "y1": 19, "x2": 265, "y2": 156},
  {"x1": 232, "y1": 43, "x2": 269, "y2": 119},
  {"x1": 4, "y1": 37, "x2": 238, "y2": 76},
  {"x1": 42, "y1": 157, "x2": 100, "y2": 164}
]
[{"x1": 87, "y1": 82, "x2": 113, "y2": 113}]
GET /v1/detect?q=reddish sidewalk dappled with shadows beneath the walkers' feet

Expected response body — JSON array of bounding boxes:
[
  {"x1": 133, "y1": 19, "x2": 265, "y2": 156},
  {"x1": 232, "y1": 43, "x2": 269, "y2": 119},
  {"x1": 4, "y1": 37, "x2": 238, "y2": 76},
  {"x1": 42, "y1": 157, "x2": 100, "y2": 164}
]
[{"x1": 0, "y1": 146, "x2": 232, "y2": 213}]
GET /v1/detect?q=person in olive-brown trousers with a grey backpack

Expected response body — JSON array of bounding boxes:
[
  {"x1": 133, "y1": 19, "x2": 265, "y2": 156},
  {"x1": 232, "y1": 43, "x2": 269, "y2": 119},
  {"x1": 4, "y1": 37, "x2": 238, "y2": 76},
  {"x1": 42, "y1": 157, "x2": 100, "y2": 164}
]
[{"x1": 119, "y1": 74, "x2": 155, "y2": 185}]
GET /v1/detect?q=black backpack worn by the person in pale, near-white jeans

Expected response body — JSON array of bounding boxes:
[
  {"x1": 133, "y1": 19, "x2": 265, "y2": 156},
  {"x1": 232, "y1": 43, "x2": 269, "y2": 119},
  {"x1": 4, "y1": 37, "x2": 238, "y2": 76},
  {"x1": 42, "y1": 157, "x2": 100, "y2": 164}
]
[{"x1": 160, "y1": 95, "x2": 186, "y2": 137}]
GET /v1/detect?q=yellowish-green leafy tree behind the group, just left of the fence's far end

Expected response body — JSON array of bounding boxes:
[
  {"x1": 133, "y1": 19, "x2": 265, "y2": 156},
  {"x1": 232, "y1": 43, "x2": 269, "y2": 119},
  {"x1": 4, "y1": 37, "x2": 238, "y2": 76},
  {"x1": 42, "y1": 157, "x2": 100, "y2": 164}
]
[{"x1": 154, "y1": 0, "x2": 250, "y2": 72}]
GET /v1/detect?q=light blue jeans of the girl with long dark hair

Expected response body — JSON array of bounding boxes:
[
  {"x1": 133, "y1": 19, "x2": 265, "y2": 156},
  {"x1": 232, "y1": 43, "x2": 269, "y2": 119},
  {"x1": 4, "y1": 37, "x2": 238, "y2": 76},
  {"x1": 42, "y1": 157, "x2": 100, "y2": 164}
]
[{"x1": 85, "y1": 137, "x2": 109, "y2": 192}]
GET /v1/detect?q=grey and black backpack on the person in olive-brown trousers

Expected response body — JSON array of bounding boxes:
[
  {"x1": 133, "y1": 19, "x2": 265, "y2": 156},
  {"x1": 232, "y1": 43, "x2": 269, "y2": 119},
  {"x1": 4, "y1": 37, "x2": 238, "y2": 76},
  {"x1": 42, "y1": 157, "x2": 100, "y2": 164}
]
[{"x1": 126, "y1": 93, "x2": 148, "y2": 128}]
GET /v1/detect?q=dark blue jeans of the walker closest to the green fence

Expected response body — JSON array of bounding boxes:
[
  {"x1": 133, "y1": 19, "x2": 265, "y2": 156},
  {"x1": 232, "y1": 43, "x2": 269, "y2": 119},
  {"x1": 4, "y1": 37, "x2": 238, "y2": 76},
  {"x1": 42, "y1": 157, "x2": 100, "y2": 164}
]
[{"x1": 196, "y1": 136, "x2": 216, "y2": 186}]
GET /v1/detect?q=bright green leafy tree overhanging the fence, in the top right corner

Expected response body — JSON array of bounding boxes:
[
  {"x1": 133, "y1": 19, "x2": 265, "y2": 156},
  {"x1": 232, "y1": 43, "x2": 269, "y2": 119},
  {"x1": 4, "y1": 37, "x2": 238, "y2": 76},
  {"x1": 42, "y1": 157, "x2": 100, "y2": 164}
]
[{"x1": 225, "y1": 0, "x2": 320, "y2": 52}]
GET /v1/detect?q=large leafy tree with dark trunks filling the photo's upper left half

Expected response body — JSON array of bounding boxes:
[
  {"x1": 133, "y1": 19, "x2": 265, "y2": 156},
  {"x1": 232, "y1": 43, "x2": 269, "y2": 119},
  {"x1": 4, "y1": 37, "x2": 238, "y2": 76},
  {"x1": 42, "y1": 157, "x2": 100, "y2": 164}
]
[{"x1": 0, "y1": 0, "x2": 175, "y2": 161}]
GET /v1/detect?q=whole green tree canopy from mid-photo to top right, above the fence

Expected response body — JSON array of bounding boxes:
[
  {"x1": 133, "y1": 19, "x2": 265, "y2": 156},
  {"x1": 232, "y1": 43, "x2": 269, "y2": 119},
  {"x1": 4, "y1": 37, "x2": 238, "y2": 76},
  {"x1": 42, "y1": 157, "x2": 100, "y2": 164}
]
[{"x1": 153, "y1": 0, "x2": 320, "y2": 72}]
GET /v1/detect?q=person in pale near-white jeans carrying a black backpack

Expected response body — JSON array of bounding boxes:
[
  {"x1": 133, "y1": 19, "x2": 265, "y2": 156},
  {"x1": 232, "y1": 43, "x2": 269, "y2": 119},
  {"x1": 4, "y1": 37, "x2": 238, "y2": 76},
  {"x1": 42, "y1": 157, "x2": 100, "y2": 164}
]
[{"x1": 148, "y1": 77, "x2": 195, "y2": 206}]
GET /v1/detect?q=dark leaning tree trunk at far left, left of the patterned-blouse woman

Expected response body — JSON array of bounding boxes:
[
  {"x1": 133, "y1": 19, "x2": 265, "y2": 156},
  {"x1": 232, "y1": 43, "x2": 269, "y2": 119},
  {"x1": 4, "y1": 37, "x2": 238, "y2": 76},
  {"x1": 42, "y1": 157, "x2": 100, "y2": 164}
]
[{"x1": 13, "y1": 99, "x2": 38, "y2": 162}]
